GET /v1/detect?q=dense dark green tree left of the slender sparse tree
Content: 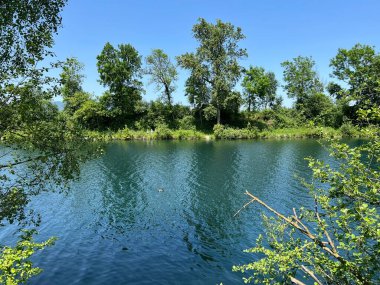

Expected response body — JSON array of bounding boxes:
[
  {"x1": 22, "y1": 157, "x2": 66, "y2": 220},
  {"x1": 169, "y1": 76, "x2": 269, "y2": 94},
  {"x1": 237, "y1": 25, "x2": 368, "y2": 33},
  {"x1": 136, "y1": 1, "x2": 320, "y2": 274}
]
[{"x1": 97, "y1": 43, "x2": 142, "y2": 127}]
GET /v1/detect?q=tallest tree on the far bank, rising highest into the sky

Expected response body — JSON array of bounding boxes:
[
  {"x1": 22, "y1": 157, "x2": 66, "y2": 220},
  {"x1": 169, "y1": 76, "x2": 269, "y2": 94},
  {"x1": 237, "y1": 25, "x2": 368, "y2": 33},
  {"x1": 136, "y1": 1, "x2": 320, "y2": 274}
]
[{"x1": 177, "y1": 18, "x2": 247, "y2": 124}]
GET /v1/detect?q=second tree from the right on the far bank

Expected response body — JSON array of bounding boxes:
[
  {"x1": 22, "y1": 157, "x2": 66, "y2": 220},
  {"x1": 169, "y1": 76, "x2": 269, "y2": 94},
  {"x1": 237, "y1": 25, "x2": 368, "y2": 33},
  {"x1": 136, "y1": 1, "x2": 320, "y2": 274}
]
[{"x1": 281, "y1": 56, "x2": 323, "y2": 107}]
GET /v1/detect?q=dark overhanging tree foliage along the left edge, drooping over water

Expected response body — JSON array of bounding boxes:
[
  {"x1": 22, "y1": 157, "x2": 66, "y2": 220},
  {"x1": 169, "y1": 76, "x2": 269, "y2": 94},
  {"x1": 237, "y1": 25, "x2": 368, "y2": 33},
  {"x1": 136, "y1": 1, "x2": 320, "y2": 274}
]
[{"x1": 0, "y1": 1, "x2": 82, "y2": 226}]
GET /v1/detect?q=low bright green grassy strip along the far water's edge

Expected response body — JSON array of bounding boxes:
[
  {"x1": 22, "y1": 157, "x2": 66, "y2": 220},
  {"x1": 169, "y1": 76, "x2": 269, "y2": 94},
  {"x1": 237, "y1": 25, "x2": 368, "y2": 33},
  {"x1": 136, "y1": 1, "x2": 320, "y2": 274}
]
[{"x1": 85, "y1": 122, "x2": 367, "y2": 141}]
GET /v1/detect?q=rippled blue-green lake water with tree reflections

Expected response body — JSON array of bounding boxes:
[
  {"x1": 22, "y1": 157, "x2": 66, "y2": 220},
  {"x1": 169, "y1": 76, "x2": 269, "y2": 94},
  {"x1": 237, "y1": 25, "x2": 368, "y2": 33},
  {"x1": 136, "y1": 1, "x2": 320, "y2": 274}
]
[{"x1": 0, "y1": 140, "x2": 360, "y2": 285}]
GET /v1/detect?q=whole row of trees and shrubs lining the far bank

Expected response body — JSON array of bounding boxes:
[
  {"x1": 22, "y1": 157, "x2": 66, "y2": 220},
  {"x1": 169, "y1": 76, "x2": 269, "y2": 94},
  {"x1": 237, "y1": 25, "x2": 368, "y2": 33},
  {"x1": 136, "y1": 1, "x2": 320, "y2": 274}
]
[{"x1": 60, "y1": 19, "x2": 380, "y2": 131}]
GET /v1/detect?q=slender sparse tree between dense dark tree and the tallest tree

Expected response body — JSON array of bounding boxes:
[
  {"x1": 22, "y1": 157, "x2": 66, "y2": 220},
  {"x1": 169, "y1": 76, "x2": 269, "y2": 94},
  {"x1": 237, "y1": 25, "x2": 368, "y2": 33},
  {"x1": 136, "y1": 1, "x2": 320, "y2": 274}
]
[{"x1": 145, "y1": 49, "x2": 178, "y2": 106}]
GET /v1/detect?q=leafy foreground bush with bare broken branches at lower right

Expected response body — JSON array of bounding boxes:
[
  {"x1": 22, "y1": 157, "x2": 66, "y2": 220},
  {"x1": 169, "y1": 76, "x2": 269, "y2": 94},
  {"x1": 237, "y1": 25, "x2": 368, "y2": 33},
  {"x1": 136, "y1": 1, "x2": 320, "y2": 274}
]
[{"x1": 233, "y1": 108, "x2": 380, "y2": 284}]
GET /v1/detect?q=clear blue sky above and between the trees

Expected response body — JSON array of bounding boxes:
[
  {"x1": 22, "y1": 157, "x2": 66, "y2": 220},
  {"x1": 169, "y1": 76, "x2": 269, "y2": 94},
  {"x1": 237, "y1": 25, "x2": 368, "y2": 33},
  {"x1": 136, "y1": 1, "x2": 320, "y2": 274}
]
[{"x1": 53, "y1": 0, "x2": 380, "y2": 106}]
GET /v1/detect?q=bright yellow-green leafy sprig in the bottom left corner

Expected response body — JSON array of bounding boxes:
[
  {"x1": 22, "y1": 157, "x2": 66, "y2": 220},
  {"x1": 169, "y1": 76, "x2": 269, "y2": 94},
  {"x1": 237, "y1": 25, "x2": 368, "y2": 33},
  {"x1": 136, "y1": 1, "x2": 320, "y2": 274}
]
[{"x1": 0, "y1": 231, "x2": 55, "y2": 285}]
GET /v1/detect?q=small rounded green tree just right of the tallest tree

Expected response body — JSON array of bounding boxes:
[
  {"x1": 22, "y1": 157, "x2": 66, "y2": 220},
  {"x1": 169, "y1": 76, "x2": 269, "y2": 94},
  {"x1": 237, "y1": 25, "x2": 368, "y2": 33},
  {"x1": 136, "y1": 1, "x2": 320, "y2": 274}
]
[{"x1": 242, "y1": 66, "x2": 278, "y2": 112}]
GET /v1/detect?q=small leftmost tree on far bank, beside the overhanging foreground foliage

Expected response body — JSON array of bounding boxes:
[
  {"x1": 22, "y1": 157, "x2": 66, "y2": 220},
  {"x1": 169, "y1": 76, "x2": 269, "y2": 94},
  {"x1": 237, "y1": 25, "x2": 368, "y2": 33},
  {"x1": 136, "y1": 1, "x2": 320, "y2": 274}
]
[{"x1": 60, "y1": 58, "x2": 84, "y2": 115}]
